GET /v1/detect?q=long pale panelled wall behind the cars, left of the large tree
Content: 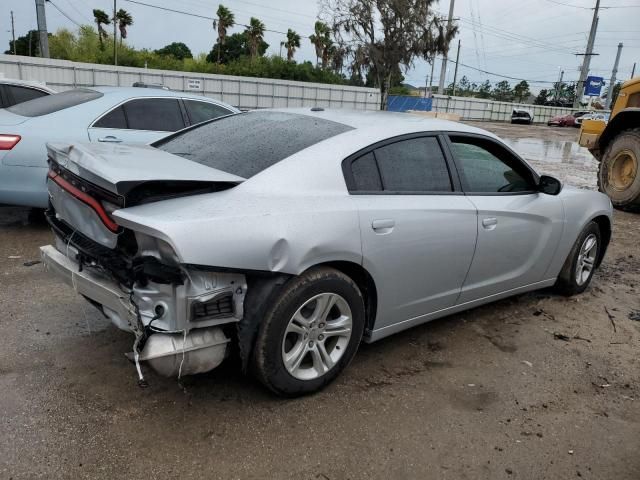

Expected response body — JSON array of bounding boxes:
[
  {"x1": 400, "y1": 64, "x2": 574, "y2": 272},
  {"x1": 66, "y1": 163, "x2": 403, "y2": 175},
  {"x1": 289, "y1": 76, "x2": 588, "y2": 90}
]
[{"x1": 0, "y1": 55, "x2": 380, "y2": 110}]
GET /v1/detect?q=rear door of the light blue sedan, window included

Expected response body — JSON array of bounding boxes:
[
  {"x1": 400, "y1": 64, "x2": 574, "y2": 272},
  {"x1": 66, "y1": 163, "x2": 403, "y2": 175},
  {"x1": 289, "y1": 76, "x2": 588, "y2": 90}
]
[{"x1": 89, "y1": 97, "x2": 186, "y2": 144}]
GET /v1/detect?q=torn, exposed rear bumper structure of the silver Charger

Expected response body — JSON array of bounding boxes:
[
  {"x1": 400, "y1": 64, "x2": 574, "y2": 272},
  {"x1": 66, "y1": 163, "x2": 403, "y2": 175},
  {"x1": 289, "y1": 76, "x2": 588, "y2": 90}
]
[{"x1": 40, "y1": 244, "x2": 246, "y2": 380}]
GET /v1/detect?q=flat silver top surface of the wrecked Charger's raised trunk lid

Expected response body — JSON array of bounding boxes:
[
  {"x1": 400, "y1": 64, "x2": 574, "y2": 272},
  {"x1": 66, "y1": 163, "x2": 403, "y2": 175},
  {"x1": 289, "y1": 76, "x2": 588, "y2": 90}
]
[{"x1": 47, "y1": 143, "x2": 244, "y2": 195}]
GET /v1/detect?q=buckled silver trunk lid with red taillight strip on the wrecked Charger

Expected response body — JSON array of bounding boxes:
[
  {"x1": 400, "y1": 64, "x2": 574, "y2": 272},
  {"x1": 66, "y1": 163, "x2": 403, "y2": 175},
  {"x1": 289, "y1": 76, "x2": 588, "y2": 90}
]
[{"x1": 47, "y1": 143, "x2": 244, "y2": 251}]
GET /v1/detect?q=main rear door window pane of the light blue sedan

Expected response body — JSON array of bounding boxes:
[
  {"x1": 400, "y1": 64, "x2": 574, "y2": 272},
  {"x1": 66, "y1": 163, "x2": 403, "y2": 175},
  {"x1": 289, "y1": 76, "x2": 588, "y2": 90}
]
[{"x1": 124, "y1": 98, "x2": 185, "y2": 132}]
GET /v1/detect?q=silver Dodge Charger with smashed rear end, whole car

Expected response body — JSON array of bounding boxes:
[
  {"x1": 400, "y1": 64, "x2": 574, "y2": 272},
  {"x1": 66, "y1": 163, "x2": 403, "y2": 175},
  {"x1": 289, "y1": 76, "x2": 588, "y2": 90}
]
[{"x1": 41, "y1": 108, "x2": 612, "y2": 396}]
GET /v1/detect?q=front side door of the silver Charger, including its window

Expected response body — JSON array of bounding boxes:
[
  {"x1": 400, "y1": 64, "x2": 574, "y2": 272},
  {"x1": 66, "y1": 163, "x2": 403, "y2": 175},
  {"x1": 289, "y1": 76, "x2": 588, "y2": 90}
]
[{"x1": 449, "y1": 134, "x2": 564, "y2": 303}]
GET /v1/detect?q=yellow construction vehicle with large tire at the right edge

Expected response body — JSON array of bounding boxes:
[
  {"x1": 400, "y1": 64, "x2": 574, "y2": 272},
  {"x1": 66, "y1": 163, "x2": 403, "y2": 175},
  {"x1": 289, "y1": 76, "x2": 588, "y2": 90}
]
[{"x1": 579, "y1": 77, "x2": 640, "y2": 211}]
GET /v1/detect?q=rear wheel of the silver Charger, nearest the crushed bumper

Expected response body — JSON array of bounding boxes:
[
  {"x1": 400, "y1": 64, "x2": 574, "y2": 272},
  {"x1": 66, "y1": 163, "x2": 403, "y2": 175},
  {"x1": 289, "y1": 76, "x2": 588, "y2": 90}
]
[{"x1": 253, "y1": 267, "x2": 365, "y2": 397}]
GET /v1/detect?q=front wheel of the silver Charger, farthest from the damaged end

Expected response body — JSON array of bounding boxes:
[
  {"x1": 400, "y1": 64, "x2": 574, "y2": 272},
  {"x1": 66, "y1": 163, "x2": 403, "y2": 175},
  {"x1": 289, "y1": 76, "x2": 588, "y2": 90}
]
[{"x1": 554, "y1": 222, "x2": 602, "y2": 296}]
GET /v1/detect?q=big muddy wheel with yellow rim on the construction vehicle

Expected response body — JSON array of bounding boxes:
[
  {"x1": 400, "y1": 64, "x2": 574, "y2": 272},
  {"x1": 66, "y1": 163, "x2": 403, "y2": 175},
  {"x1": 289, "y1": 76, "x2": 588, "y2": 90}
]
[{"x1": 598, "y1": 129, "x2": 640, "y2": 210}]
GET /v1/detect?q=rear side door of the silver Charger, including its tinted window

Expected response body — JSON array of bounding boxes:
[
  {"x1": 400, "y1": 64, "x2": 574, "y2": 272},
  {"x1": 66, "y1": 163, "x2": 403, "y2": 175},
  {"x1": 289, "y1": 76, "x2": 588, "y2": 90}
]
[{"x1": 343, "y1": 135, "x2": 477, "y2": 329}]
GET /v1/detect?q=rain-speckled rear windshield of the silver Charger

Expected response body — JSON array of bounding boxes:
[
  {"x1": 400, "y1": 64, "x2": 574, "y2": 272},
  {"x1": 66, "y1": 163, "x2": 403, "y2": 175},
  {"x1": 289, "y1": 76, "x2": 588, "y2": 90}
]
[{"x1": 153, "y1": 111, "x2": 352, "y2": 178}]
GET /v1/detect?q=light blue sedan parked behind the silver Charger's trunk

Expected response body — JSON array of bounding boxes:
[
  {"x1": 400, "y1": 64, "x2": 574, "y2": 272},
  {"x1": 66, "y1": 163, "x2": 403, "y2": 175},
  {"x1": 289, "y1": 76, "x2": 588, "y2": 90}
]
[{"x1": 0, "y1": 87, "x2": 239, "y2": 208}]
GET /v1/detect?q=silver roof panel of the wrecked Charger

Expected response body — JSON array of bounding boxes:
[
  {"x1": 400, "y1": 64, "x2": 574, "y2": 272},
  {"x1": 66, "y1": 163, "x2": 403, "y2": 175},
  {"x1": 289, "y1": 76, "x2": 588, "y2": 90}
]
[{"x1": 271, "y1": 108, "x2": 497, "y2": 138}]
